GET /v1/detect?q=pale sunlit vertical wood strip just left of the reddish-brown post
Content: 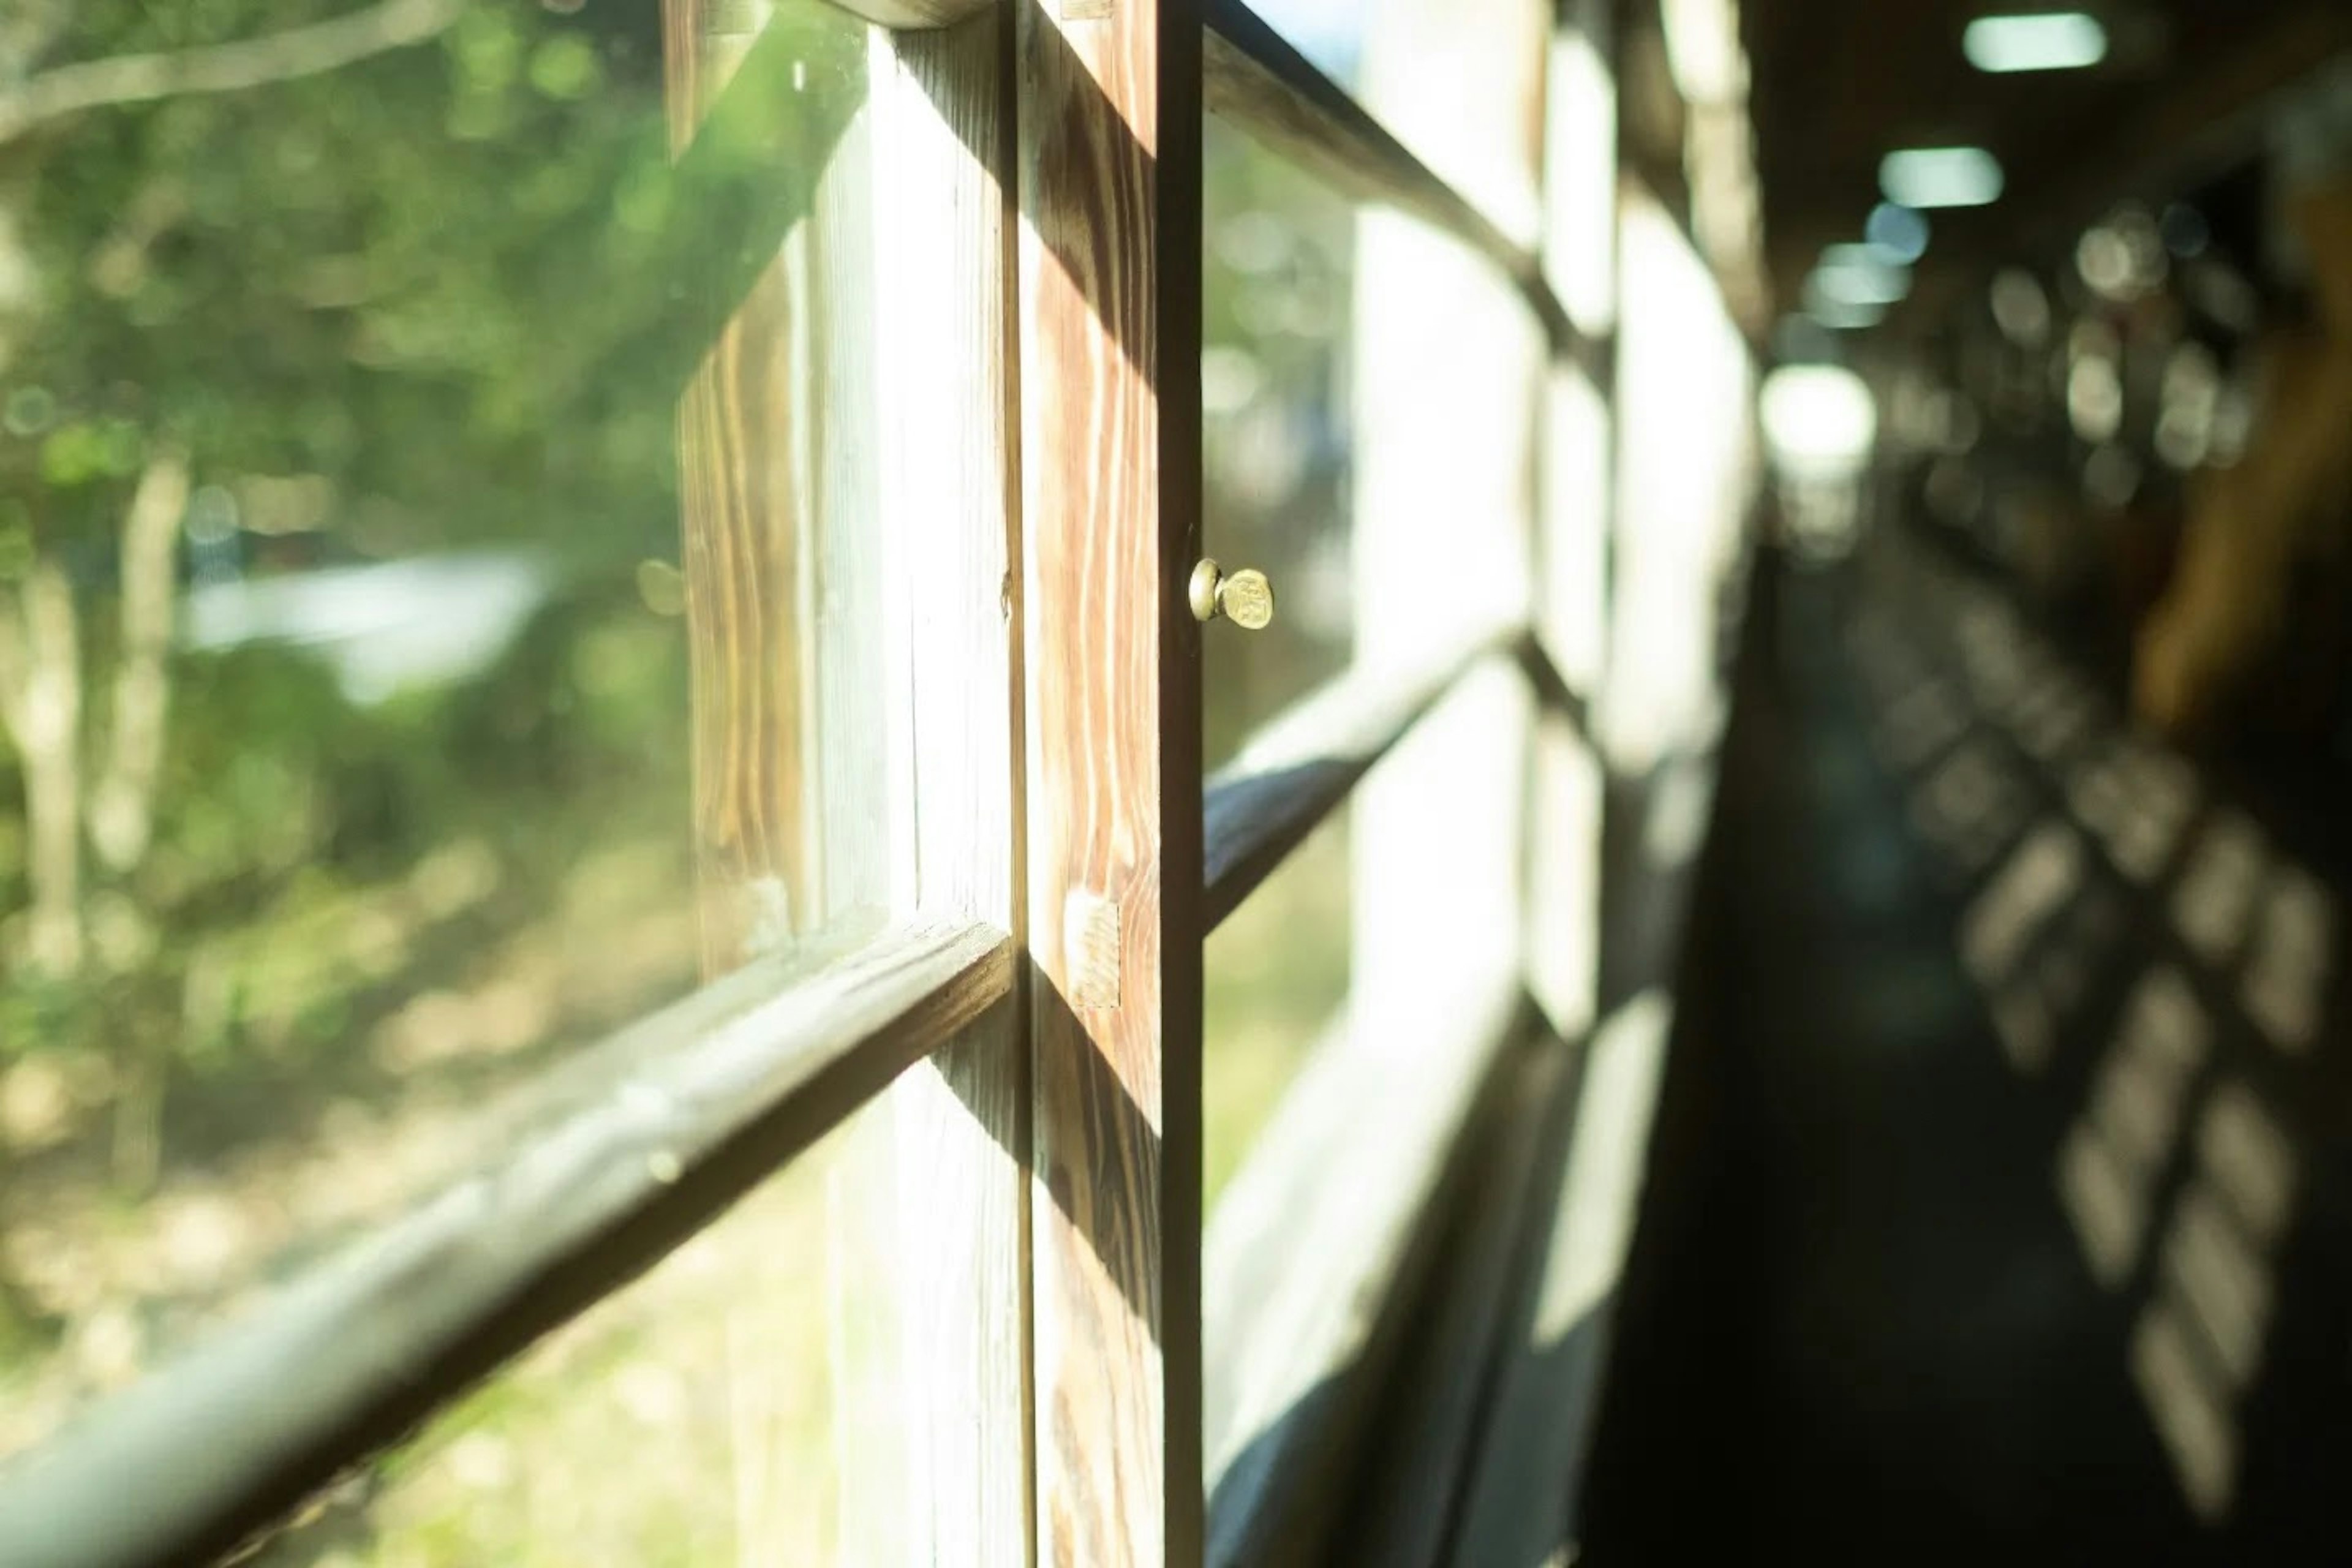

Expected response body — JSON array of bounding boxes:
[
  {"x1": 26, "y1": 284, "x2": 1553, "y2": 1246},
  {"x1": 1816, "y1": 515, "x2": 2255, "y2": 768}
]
[{"x1": 842, "y1": 9, "x2": 1033, "y2": 1568}]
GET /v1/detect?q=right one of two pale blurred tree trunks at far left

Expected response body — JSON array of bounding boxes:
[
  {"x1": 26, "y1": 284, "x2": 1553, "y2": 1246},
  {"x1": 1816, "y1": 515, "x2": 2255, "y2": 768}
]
[{"x1": 89, "y1": 447, "x2": 188, "y2": 875}]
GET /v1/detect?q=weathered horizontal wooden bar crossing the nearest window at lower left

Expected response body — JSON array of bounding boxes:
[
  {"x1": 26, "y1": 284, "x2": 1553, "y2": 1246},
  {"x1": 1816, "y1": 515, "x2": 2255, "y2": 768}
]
[{"x1": 0, "y1": 924, "x2": 1014, "y2": 1568}]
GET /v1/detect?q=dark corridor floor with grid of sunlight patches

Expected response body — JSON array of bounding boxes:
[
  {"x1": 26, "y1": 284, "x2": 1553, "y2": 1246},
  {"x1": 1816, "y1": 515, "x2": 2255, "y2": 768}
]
[{"x1": 1585, "y1": 538, "x2": 2352, "y2": 1563}]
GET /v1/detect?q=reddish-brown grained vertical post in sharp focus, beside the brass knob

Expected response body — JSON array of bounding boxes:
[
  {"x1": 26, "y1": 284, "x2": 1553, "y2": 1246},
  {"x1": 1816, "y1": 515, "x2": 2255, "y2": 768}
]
[{"x1": 1019, "y1": 0, "x2": 1202, "y2": 1566}]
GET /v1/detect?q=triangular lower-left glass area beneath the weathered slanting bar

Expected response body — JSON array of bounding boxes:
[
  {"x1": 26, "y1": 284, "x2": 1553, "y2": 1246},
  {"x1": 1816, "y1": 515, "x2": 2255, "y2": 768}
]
[{"x1": 261, "y1": 1124, "x2": 887, "y2": 1568}]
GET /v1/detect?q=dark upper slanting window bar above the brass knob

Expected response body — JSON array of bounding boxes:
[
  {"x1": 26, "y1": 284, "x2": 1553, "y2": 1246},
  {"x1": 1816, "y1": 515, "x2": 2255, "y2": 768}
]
[{"x1": 1204, "y1": 0, "x2": 1578, "y2": 355}]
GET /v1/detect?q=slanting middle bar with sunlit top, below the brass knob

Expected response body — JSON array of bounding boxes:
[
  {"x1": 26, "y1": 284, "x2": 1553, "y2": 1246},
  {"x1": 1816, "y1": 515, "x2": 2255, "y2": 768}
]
[{"x1": 1204, "y1": 630, "x2": 1526, "y2": 929}]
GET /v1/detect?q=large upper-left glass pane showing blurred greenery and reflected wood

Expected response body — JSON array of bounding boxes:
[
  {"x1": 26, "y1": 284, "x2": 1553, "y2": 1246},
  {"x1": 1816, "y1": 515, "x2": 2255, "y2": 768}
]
[{"x1": 0, "y1": 0, "x2": 899, "y2": 1457}]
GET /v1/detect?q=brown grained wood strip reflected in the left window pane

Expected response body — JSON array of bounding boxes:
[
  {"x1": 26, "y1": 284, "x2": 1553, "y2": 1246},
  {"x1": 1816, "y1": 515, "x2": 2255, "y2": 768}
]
[{"x1": 661, "y1": 0, "x2": 823, "y2": 976}]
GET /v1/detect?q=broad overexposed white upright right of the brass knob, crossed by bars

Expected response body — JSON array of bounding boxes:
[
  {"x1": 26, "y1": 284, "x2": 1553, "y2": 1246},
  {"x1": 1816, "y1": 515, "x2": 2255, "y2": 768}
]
[{"x1": 1348, "y1": 0, "x2": 1543, "y2": 1086}]
